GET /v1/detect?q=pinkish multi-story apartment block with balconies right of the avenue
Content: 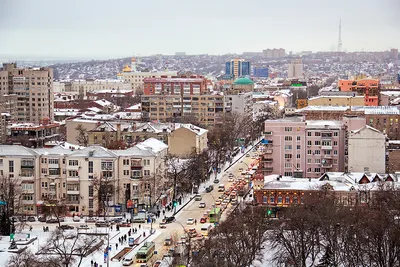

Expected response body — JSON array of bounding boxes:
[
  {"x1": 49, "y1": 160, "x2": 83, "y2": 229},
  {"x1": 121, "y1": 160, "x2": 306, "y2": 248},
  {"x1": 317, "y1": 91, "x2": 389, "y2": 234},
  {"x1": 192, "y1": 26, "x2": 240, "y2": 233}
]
[{"x1": 261, "y1": 117, "x2": 345, "y2": 178}]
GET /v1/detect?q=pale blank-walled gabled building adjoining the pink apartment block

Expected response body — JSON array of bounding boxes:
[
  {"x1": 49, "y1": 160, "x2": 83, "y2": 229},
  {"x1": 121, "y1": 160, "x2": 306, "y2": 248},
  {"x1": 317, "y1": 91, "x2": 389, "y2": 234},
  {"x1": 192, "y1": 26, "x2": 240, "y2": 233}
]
[{"x1": 348, "y1": 125, "x2": 386, "y2": 173}]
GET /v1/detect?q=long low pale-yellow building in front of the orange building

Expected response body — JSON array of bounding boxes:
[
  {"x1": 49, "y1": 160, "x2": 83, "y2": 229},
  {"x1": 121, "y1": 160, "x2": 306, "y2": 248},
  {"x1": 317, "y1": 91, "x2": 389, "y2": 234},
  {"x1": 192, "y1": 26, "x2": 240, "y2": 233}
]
[{"x1": 308, "y1": 95, "x2": 365, "y2": 107}]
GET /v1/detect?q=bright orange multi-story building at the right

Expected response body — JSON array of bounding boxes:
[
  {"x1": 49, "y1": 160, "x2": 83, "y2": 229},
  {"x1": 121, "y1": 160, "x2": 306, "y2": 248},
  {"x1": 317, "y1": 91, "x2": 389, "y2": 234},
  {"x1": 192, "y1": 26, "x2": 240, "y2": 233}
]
[{"x1": 338, "y1": 79, "x2": 380, "y2": 106}]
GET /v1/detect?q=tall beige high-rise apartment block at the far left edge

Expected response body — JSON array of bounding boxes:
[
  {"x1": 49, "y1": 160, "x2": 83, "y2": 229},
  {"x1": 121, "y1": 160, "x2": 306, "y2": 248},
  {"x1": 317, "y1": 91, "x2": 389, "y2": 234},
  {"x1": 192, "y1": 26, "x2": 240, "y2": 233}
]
[{"x1": 0, "y1": 63, "x2": 54, "y2": 123}]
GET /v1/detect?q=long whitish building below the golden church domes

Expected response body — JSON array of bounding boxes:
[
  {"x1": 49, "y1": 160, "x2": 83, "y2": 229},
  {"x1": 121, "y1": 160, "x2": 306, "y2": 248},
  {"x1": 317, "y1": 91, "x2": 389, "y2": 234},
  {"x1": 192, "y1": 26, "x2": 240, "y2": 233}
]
[{"x1": 118, "y1": 58, "x2": 178, "y2": 94}]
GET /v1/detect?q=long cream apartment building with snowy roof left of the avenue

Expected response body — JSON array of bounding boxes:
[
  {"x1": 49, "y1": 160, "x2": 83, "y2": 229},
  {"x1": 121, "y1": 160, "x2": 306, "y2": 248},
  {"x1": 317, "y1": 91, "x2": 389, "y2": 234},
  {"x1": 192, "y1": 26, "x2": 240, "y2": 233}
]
[{"x1": 0, "y1": 139, "x2": 168, "y2": 215}]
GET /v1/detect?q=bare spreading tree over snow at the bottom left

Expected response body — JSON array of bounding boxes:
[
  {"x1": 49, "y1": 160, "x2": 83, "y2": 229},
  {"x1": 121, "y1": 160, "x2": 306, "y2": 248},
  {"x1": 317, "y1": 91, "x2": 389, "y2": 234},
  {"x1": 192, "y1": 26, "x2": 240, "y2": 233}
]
[{"x1": 38, "y1": 229, "x2": 103, "y2": 267}]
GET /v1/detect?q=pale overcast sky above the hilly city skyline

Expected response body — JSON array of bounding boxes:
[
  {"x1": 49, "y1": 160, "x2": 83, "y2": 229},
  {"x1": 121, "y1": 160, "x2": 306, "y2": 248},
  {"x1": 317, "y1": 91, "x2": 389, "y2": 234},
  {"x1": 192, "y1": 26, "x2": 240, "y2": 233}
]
[{"x1": 0, "y1": 0, "x2": 400, "y2": 59}]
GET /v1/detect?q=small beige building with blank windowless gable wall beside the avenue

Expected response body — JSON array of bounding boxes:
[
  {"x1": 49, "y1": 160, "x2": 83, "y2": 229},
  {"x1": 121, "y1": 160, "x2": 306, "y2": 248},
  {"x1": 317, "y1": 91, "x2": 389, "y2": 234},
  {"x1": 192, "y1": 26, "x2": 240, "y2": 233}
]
[{"x1": 168, "y1": 124, "x2": 208, "y2": 158}]
